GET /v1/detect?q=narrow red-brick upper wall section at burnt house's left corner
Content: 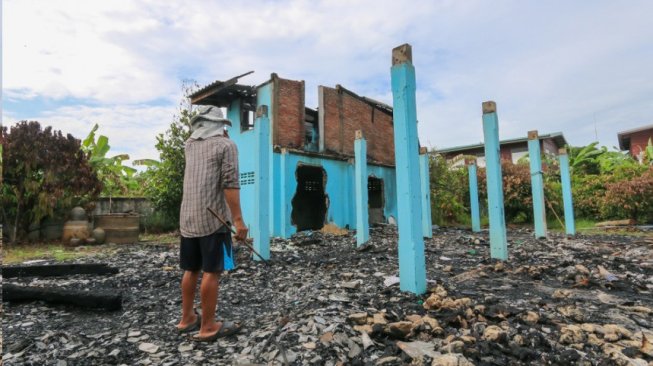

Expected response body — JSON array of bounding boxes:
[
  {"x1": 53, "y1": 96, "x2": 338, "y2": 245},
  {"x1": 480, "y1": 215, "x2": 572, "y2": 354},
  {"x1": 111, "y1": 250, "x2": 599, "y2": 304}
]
[{"x1": 272, "y1": 75, "x2": 305, "y2": 149}]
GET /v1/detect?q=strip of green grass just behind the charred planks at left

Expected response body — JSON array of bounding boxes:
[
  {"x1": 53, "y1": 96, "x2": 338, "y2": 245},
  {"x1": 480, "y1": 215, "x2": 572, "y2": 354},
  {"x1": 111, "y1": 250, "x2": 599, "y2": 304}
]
[{"x1": 2, "y1": 244, "x2": 108, "y2": 264}]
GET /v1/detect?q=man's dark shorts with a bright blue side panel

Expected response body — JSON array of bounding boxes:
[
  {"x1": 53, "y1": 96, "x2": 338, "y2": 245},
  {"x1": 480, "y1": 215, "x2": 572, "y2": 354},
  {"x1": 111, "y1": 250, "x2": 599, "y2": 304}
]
[{"x1": 179, "y1": 232, "x2": 235, "y2": 273}]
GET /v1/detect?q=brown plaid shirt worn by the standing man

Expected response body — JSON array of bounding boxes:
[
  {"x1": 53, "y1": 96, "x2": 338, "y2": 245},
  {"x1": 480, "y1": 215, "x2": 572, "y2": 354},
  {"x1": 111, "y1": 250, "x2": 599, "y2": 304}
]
[{"x1": 179, "y1": 136, "x2": 240, "y2": 238}]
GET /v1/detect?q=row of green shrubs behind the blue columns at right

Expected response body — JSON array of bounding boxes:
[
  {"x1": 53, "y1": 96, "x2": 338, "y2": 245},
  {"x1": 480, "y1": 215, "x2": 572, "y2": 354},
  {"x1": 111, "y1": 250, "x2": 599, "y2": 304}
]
[{"x1": 431, "y1": 143, "x2": 653, "y2": 224}]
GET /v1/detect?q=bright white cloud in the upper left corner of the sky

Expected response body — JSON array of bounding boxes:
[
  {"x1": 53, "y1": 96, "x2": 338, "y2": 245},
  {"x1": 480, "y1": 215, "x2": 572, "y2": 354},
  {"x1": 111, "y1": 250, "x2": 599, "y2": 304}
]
[{"x1": 3, "y1": 0, "x2": 178, "y2": 103}]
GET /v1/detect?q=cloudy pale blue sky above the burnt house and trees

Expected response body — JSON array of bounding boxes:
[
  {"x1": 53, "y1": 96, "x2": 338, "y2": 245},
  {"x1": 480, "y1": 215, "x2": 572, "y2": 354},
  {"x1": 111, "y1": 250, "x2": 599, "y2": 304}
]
[{"x1": 1, "y1": 0, "x2": 653, "y2": 163}]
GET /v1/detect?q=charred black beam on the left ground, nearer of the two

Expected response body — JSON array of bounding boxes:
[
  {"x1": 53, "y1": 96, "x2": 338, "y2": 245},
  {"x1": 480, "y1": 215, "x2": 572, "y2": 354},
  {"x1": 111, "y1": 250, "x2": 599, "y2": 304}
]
[{"x1": 2, "y1": 283, "x2": 122, "y2": 311}]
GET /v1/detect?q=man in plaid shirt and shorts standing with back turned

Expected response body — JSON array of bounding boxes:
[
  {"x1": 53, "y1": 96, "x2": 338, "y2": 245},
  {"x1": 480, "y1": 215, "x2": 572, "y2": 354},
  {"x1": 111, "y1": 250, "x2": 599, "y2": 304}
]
[{"x1": 177, "y1": 106, "x2": 247, "y2": 341}]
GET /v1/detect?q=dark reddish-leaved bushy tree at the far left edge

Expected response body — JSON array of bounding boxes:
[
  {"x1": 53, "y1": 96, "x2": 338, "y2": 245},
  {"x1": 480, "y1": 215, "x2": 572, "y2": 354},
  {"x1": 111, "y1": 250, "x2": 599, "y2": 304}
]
[{"x1": 0, "y1": 121, "x2": 102, "y2": 243}]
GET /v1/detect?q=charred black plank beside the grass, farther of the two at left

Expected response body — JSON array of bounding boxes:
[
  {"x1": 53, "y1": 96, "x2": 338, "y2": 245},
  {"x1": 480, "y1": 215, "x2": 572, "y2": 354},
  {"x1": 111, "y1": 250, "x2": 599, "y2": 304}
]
[{"x1": 2, "y1": 263, "x2": 118, "y2": 278}]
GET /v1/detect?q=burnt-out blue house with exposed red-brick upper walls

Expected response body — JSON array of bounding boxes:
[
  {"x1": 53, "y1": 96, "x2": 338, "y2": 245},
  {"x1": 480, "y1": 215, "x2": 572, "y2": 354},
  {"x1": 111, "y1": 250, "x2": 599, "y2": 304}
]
[{"x1": 190, "y1": 74, "x2": 404, "y2": 238}]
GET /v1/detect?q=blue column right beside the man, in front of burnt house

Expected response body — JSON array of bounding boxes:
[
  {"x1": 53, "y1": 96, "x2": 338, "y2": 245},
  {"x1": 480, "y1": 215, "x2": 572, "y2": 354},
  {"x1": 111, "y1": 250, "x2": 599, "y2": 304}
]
[{"x1": 252, "y1": 105, "x2": 272, "y2": 261}]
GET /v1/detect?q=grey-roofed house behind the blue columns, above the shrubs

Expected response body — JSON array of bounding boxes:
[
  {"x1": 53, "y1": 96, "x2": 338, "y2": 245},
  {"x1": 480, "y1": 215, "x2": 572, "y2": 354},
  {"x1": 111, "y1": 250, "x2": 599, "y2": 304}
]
[{"x1": 435, "y1": 132, "x2": 567, "y2": 167}]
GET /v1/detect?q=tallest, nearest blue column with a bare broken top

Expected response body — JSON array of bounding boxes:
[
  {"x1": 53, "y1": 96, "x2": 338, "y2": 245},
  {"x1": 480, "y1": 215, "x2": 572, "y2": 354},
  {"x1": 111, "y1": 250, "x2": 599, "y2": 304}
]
[{"x1": 390, "y1": 44, "x2": 426, "y2": 294}]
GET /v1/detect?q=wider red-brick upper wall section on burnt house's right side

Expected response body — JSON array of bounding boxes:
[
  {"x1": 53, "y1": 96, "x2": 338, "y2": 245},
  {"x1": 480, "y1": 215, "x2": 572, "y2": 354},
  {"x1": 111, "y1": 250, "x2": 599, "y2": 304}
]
[{"x1": 319, "y1": 87, "x2": 395, "y2": 165}]
